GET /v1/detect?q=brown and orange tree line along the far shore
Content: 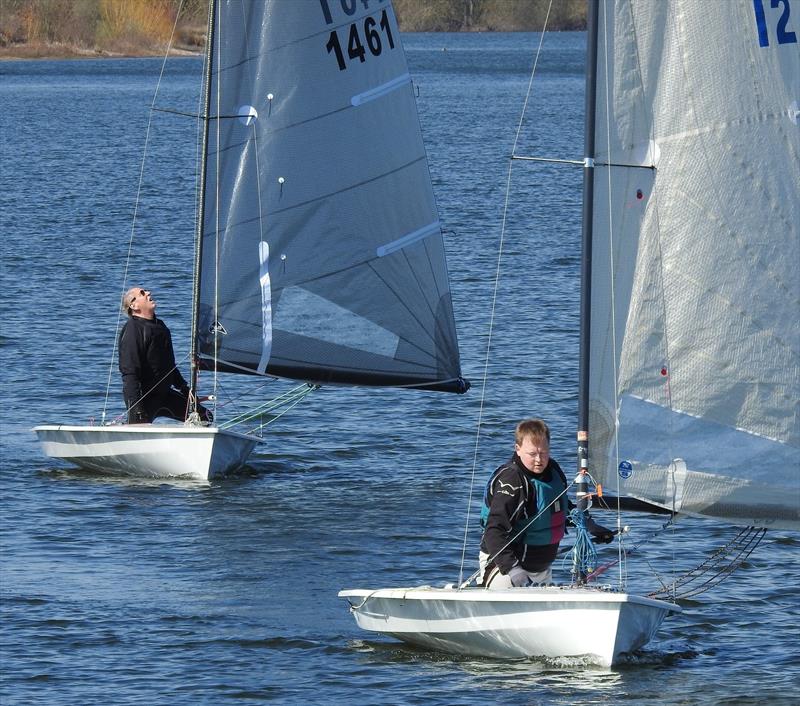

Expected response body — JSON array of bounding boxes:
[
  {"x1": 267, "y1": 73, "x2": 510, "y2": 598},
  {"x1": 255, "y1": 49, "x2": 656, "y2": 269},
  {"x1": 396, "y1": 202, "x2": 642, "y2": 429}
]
[{"x1": 0, "y1": 0, "x2": 586, "y2": 56}]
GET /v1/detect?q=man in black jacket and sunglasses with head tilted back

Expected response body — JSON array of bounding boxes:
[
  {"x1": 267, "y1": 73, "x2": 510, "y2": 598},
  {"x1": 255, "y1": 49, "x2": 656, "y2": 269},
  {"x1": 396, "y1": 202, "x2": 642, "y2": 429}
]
[{"x1": 119, "y1": 287, "x2": 212, "y2": 424}]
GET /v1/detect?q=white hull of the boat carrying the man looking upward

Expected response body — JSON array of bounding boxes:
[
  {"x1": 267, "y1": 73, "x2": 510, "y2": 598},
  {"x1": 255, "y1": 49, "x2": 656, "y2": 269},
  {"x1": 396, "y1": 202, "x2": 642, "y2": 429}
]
[{"x1": 33, "y1": 424, "x2": 259, "y2": 480}]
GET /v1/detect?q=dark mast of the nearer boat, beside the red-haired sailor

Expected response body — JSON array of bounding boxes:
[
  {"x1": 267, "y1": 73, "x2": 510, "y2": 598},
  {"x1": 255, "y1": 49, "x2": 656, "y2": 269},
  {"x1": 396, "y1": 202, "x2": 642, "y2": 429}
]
[{"x1": 577, "y1": 0, "x2": 600, "y2": 582}]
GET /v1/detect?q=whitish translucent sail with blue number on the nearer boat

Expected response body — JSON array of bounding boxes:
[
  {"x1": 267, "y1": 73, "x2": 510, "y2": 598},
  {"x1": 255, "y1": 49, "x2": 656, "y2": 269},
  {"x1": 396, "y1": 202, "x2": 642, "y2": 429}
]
[{"x1": 589, "y1": 0, "x2": 800, "y2": 528}]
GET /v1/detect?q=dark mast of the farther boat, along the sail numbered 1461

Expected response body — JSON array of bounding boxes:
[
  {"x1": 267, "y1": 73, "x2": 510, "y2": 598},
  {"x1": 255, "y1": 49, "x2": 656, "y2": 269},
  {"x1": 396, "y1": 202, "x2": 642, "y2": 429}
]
[{"x1": 189, "y1": 0, "x2": 217, "y2": 411}]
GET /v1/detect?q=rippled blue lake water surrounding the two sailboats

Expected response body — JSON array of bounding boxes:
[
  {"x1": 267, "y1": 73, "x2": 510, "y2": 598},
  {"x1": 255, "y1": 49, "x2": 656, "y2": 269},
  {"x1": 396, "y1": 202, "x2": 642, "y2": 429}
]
[{"x1": 0, "y1": 33, "x2": 800, "y2": 705}]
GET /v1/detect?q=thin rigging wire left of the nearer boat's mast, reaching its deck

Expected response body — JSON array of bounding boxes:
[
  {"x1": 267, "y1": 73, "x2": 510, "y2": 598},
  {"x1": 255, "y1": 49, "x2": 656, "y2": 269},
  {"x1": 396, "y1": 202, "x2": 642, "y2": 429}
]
[{"x1": 458, "y1": 0, "x2": 553, "y2": 589}]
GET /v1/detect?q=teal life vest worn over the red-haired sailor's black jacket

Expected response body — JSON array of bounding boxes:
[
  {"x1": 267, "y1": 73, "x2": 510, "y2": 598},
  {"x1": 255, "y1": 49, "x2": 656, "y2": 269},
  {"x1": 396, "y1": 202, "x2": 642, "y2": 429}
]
[{"x1": 480, "y1": 466, "x2": 569, "y2": 546}]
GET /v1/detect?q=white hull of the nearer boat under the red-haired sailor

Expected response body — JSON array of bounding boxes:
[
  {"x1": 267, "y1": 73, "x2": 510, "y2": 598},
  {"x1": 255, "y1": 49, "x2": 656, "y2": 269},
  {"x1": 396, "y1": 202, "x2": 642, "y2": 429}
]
[{"x1": 339, "y1": 586, "x2": 681, "y2": 667}]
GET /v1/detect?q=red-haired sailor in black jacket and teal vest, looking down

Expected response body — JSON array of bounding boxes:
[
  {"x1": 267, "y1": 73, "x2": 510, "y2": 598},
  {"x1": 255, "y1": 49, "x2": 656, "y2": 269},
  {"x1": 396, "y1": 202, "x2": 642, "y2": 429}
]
[{"x1": 479, "y1": 419, "x2": 613, "y2": 588}]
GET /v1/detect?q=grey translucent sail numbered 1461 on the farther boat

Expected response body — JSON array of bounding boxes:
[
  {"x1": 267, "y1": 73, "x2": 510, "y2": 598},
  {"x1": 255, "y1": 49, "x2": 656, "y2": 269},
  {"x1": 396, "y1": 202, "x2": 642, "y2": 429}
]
[{"x1": 197, "y1": 0, "x2": 466, "y2": 392}]
